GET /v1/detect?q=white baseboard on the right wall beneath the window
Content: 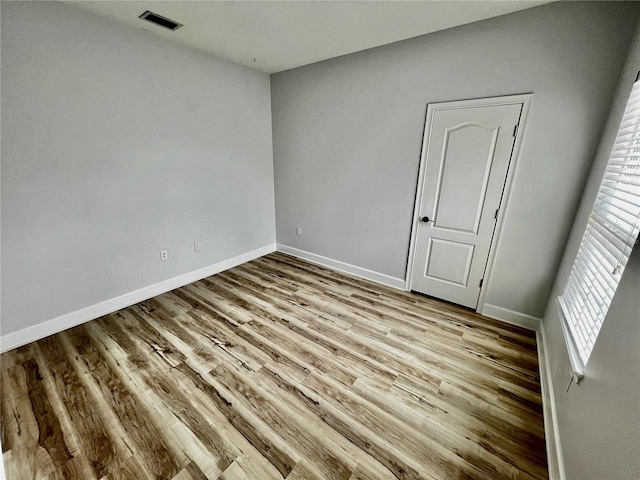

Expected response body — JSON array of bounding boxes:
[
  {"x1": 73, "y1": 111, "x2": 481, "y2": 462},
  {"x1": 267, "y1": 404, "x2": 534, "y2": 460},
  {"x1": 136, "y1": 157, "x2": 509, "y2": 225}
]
[{"x1": 536, "y1": 323, "x2": 566, "y2": 480}]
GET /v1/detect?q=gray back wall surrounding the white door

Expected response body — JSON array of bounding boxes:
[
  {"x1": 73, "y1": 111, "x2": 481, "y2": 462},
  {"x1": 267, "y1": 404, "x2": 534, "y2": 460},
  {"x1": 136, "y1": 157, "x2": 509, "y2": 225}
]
[{"x1": 271, "y1": 2, "x2": 640, "y2": 317}]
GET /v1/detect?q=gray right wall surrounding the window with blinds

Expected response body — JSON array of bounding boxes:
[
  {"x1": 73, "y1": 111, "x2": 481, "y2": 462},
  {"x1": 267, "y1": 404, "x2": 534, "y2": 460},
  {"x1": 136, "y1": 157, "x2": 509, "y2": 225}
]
[{"x1": 544, "y1": 21, "x2": 640, "y2": 480}]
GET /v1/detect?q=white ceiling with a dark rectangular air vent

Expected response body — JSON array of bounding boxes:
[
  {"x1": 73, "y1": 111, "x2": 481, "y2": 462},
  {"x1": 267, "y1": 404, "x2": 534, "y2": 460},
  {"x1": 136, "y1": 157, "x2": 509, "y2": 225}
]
[{"x1": 64, "y1": 0, "x2": 549, "y2": 73}]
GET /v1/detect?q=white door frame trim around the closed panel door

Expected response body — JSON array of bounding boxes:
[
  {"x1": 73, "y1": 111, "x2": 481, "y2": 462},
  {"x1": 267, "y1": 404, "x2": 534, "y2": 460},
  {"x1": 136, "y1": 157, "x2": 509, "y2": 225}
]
[{"x1": 404, "y1": 93, "x2": 533, "y2": 313}]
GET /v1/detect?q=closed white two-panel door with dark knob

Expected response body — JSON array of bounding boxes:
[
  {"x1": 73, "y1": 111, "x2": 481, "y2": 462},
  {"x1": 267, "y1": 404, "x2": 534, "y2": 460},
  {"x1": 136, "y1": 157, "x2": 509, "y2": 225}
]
[{"x1": 410, "y1": 100, "x2": 523, "y2": 309}]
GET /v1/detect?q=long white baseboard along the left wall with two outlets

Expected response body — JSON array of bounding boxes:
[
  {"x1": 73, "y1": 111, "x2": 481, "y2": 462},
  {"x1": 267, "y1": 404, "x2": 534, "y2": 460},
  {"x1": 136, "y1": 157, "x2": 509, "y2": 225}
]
[{"x1": 0, "y1": 244, "x2": 276, "y2": 352}]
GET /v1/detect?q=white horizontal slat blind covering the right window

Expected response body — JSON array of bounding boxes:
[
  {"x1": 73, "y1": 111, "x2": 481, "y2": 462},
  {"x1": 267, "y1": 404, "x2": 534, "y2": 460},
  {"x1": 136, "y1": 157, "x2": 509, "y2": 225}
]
[{"x1": 558, "y1": 78, "x2": 640, "y2": 375}]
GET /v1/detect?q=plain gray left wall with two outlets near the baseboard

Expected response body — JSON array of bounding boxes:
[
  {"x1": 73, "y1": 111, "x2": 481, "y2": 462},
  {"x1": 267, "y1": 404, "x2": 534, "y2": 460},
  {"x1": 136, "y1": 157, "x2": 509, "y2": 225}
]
[{"x1": 1, "y1": 2, "x2": 275, "y2": 335}]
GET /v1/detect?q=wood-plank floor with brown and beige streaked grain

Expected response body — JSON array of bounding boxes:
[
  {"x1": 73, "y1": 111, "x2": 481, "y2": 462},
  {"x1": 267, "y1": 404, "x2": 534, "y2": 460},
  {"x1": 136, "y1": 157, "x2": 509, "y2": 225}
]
[{"x1": 1, "y1": 253, "x2": 547, "y2": 480}]
